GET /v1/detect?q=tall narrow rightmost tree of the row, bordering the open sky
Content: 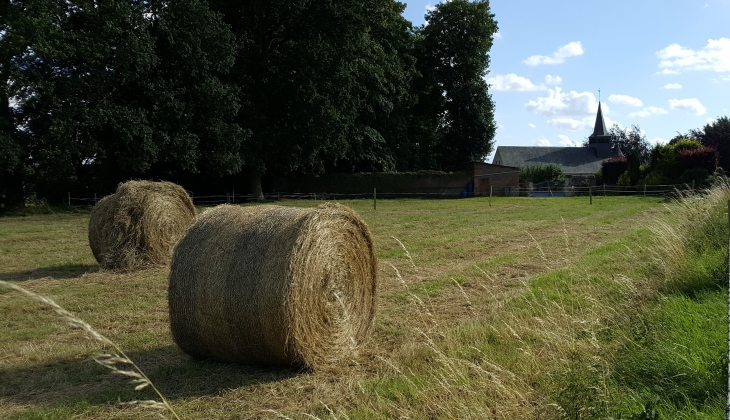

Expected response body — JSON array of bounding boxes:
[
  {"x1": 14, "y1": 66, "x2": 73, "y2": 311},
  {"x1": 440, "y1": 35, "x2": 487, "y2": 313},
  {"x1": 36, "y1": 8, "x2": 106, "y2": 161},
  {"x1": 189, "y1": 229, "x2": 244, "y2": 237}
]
[{"x1": 417, "y1": 0, "x2": 498, "y2": 170}]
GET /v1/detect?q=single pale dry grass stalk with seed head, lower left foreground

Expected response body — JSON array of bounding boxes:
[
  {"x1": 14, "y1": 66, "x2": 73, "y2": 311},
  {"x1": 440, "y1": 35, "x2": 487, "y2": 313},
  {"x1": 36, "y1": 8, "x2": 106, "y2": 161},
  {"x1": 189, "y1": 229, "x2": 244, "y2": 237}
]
[{"x1": 0, "y1": 280, "x2": 180, "y2": 420}]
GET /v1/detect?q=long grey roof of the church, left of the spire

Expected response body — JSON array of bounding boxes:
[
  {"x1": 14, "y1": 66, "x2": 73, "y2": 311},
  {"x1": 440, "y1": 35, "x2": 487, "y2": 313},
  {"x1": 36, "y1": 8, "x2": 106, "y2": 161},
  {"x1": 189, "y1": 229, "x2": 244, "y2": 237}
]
[{"x1": 492, "y1": 146, "x2": 605, "y2": 175}]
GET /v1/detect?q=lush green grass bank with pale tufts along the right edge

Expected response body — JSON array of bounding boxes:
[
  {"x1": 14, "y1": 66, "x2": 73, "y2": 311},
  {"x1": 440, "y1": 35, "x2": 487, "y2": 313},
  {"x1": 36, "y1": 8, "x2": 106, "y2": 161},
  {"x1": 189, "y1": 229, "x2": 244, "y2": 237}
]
[{"x1": 617, "y1": 179, "x2": 730, "y2": 419}]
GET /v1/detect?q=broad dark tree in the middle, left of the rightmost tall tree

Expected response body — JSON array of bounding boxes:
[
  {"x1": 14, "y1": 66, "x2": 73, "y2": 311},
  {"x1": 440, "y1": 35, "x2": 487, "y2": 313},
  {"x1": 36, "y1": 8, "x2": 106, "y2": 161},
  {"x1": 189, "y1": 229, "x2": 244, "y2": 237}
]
[{"x1": 210, "y1": 0, "x2": 412, "y2": 192}]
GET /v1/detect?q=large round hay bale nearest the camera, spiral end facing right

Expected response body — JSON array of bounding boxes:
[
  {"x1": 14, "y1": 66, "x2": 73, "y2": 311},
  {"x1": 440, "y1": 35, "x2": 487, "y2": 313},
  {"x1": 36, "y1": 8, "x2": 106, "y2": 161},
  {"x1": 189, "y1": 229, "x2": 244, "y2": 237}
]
[{"x1": 169, "y1": 204, "x2": 377, "y2": 369}]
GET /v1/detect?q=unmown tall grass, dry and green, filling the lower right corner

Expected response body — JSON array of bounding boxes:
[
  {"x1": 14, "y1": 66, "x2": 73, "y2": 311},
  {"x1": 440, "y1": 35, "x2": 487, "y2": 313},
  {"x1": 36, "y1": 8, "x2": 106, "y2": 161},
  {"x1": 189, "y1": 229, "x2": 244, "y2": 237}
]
[{"x1": 332, "y1": 182, "x2": 730, "y2": 420}]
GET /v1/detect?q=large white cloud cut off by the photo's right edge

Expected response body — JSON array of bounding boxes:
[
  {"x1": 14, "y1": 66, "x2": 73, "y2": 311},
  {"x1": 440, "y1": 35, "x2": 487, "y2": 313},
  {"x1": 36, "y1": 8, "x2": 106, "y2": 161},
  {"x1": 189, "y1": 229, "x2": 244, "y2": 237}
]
[{"x1": 656, "y1": 38, "x2": 730, "y2": 74}]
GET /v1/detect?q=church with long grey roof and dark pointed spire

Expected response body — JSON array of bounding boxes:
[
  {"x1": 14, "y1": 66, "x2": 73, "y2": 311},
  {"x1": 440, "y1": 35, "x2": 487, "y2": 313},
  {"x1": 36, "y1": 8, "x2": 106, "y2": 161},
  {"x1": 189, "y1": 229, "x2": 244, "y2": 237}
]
[{"x1": 492, "y1": 102, "x2": 623, "y2": 185}]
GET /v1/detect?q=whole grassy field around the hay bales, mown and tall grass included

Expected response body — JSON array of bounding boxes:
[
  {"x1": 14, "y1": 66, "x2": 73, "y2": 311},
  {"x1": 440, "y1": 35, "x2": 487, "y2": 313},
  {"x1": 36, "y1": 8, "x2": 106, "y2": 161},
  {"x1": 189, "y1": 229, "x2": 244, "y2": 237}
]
[{"x1": 0, "y1": 197, "x2": 727, "y2": 419}]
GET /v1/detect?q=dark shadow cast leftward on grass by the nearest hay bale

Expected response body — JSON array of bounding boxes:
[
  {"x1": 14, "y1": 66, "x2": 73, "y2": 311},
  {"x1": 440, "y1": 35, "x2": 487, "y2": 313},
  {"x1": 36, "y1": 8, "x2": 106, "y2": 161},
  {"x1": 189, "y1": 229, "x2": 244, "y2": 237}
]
[{"x1": 0, "y1": 345, "x2": 303, "y2": 409}]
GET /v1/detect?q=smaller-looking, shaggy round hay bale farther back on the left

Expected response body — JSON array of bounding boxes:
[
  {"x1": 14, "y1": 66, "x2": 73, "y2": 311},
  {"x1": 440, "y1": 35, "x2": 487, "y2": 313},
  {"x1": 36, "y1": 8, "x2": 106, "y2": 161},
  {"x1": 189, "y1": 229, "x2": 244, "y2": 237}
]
[{"x1": 89, "y1": 181, "x2": 195, "y2": 271}]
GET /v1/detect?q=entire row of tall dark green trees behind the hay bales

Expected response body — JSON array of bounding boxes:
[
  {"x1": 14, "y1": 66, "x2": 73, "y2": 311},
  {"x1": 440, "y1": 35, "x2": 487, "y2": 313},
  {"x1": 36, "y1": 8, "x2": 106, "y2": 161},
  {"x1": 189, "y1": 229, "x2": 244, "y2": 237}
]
[{"x1": 0, "y1": 0, "x2": 497, "y2": 206}]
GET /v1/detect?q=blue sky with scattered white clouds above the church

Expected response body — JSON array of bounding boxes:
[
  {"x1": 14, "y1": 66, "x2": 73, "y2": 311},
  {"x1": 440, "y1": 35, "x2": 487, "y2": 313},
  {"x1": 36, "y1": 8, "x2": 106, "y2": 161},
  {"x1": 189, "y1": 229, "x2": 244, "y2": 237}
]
[{"x1": 404, "y1": 0, "x2": 730, "y2": 158}]
